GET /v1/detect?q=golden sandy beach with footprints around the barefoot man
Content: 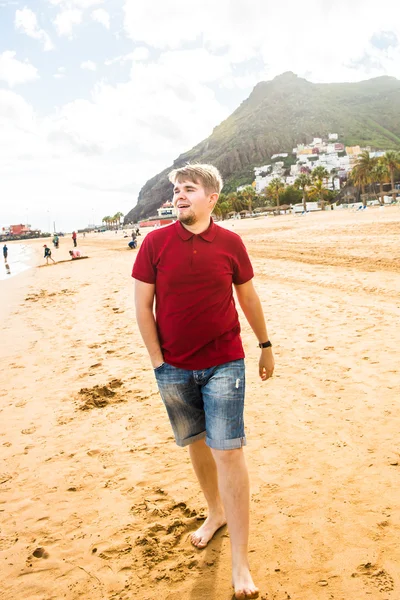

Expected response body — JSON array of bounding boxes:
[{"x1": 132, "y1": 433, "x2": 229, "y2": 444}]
[{"x1": 0, "y1": 206, "x2": 400, "y2": 600}]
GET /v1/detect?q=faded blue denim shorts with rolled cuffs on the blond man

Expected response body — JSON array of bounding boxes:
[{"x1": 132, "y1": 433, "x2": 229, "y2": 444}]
[{"x1": 154, "y1": 358, "x2": 246, "y2": 450}]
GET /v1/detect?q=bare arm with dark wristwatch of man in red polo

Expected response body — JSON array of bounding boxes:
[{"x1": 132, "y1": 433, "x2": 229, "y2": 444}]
[{"x1": 235, "y1": 279, "x2": 275, "y2": 381}]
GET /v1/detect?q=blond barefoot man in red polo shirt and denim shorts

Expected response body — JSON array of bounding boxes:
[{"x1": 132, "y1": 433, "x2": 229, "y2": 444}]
[{"x1": 132, "y1": 165, "x2": 274, "y2": 599}]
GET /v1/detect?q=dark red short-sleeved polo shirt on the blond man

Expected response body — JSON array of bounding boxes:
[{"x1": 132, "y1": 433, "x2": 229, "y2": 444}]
[{"x1": 132, "y1": 219, "x2": 254, "y2": 370}]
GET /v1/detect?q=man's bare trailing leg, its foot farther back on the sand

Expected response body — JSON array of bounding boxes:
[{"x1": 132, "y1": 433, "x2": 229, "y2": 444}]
[{"x1": 189, "y1": 439, "x2": 226, "y2": 548}]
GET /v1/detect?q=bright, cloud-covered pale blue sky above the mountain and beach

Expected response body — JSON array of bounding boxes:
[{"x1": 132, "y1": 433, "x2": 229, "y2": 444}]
[{"x1": 0, "y1": 0, "x2": 400, "y2": 232}]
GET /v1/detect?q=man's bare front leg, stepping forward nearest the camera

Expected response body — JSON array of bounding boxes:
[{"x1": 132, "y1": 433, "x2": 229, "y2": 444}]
[{"x1": 212, "y1": 448, "x2": 258, "y2": 600}]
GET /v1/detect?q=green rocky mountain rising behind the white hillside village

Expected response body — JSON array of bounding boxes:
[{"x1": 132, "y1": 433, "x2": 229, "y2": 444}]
[{"x1": 125, "y1": 72, "x2": 400, "y2": 223}]
